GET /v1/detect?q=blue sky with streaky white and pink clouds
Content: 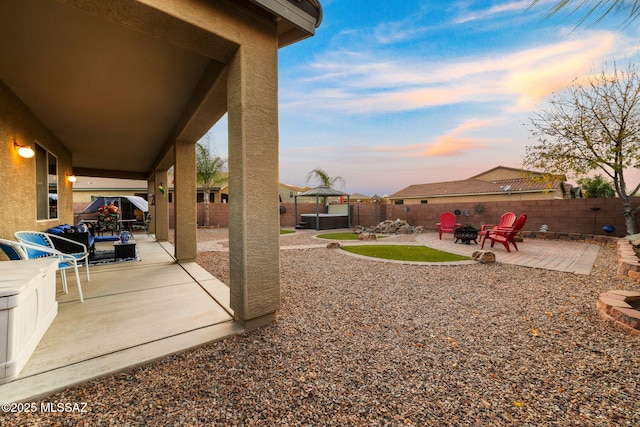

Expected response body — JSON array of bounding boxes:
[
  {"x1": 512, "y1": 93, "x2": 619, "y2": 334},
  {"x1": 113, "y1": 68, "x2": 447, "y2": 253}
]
[{"x1": 204, "y1": 0, "x2": 640, "y2": 196}]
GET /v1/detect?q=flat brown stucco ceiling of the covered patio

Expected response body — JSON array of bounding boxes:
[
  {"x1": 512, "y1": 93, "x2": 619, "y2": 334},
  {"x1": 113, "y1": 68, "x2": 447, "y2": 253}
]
[{"x1": 0, "y1": 0, "x2": 225, "y2": 177}]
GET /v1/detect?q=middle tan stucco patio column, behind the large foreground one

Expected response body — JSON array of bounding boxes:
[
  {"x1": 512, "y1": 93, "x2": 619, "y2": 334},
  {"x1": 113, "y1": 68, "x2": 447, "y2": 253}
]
[{"x1": 173, "y1": 141, "x2": 198, "y2": 262}]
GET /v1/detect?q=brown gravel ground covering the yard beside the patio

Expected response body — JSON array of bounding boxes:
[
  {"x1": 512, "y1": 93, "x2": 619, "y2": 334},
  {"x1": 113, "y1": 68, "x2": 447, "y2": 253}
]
[{"x1": 6, "y1": 230, "x2": 640, "y2": 426}]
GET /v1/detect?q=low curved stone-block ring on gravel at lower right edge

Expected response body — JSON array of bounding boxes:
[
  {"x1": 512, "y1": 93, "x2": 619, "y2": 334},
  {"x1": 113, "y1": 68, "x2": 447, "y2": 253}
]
[{"x1": 598, "y1": 290, "x2": 640, "y2": 336}]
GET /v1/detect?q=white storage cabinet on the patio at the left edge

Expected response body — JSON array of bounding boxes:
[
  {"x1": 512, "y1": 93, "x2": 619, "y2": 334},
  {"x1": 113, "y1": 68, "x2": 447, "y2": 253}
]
[{"x1": 0, "y1": 258, "x2": 58, "y2": 384}]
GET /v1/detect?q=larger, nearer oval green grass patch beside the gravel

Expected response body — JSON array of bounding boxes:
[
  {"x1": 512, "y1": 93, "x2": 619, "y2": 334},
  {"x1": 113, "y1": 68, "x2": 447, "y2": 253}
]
[{"x1": 342, "y1": 245, "x2": 471, "y2": 262}]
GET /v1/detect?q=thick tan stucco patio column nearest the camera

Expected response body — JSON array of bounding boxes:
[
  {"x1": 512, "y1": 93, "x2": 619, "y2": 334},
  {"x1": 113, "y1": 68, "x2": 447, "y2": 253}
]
[{"x1": 227, "y1": 37, "x2": 280, "y2": 329}]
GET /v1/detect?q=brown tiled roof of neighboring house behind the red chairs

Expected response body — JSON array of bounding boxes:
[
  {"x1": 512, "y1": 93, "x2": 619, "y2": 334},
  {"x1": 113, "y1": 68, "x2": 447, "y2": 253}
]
[{"x1": 389, "y1": 166, "x2": 567, "y2": 200}]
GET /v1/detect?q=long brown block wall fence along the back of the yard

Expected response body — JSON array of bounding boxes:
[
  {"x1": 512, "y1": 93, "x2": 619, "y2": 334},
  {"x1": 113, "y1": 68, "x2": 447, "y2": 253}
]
[{"x1": 169, "y1": 198, "x2": 640, "y2": 237}]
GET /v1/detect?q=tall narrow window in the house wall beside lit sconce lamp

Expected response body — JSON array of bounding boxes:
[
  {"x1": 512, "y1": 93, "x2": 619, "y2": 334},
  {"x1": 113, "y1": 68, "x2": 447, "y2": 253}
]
[{"x1": 35, "y1": 142, "x2": 58, "y2": 220}]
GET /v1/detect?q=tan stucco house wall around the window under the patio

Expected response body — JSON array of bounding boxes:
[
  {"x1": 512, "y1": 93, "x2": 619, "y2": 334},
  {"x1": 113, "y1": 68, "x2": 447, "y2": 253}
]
[{"x1": 0, "y1": 81, "x2": 73, "y2": 239}]
